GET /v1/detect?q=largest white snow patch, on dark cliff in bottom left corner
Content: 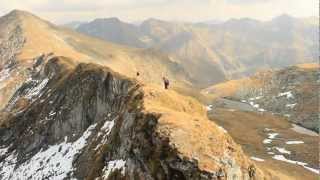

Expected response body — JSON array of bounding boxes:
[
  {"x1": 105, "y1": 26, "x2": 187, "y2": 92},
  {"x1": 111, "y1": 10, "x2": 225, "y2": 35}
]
[{"x1": 0, "y1": 124, "x2": 96, "y2": 180}]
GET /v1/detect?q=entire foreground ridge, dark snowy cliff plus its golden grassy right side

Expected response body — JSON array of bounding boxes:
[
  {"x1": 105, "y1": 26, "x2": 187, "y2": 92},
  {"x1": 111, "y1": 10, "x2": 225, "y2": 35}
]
[{"x1": 0, "y1": 57, "x2": 264, "y2": 180}]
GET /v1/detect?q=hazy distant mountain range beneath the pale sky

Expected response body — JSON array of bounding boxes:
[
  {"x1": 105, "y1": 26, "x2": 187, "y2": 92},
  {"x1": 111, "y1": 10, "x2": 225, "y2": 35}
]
[{"x1": 76, "y1": 15, "x2": 319, "y2": 86}]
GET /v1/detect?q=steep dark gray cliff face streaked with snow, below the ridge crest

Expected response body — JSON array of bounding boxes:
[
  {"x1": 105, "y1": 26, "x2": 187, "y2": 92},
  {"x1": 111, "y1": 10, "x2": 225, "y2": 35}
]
[{"x1": 0, "y1": 57, "x2": 258, "y2": 180}]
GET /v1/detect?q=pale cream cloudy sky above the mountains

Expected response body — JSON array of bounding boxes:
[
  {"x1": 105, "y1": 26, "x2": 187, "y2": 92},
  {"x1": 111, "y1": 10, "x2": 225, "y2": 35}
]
[{"x1": 0, "y1": 0, "x2": 319, "y2": 24}]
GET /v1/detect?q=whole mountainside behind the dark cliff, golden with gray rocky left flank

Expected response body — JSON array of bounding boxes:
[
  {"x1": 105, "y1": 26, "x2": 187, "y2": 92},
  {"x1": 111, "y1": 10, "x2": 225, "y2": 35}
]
[{"x1": 0, "y1": 10, "x2": 191, "y2": 109}]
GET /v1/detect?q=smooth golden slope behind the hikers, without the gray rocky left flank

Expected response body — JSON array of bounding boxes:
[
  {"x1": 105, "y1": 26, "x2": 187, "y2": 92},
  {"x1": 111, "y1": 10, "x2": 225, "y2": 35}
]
[{"x1": 1, "y1": 10, "x2": 188, "y2": 84}]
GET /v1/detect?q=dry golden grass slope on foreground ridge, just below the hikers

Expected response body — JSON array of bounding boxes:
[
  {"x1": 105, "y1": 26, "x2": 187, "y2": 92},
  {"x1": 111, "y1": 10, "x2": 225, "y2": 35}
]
[{"x1": 142, "y1": 86, "x2": 258, "y2": 174}]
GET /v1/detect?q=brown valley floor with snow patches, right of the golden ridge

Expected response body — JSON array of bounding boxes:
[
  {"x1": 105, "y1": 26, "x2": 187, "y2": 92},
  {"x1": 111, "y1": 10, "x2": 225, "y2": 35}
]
[{"x1": 208, "y1": 97, "x2": 319, "y2": 180}]
